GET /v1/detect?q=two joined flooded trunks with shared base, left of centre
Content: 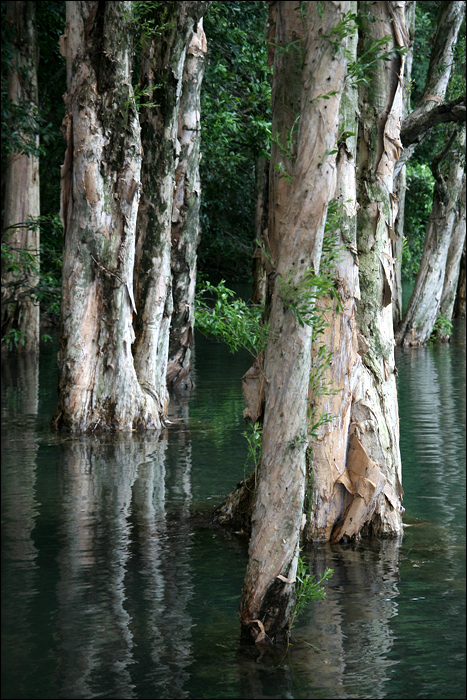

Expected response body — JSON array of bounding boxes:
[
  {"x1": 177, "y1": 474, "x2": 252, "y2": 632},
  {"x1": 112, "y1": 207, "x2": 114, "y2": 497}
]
[{"x1": 53, "y1": 2, "x2": 210, "y2": 431}]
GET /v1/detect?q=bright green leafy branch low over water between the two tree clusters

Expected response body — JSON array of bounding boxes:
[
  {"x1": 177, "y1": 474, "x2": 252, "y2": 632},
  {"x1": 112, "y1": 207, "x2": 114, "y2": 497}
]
[{"x1": 195, "y1": 280, "x2": 268, "y2": 357}]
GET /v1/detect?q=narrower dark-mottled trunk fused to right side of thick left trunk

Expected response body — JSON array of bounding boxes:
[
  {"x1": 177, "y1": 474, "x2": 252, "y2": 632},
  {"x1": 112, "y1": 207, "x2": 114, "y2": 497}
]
[{"x1": 133, "y1": 2, "x2": 207, "y2": 415}]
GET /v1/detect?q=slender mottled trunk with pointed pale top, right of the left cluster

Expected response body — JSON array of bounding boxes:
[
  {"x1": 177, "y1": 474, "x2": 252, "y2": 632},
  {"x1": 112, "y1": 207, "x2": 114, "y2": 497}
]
[{"x1": 167, "y1": 19, "x2": 207, "y2": 389}]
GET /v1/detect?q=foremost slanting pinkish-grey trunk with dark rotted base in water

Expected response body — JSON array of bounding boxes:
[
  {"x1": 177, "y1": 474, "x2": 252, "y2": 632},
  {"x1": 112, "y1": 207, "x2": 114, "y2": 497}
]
[{"x1": 240, "y1": 2, "x2": 349, "y2": 641}]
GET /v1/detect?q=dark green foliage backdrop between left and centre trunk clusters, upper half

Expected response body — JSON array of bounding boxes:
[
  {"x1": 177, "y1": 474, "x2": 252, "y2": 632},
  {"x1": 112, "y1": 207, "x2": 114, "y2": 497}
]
[{"x1": 199, "y1": 0, "x2": 271, "y2": 278}]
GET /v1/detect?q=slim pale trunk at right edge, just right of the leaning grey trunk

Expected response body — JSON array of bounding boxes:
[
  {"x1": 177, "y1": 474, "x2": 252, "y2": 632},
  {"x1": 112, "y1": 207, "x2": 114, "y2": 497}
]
[{"x1": 438, "y1": 171, "x2": 465, "y2": 330}]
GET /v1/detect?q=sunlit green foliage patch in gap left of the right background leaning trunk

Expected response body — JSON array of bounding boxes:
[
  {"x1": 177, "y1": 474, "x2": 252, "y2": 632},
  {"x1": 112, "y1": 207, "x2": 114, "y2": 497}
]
[{"x1": 402, "y1": 160, "x2": 435, "y2": 280}]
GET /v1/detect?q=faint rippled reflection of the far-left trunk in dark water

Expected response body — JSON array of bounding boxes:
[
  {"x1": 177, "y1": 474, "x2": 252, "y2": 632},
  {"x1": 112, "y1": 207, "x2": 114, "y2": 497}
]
[{"x1": 1, "y1": 355, "x2": 40, "y2": 697}]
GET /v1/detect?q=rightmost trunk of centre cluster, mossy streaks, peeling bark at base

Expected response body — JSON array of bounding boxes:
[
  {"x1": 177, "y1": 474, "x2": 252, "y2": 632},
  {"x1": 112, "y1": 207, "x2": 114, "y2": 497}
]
[{"x1": 331, "y1": 2, "x2": 408, "y2": 541}]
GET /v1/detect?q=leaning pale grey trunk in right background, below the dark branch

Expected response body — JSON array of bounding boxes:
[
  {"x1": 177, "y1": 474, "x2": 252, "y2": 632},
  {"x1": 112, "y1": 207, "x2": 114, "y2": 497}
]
[{"x1": 396, "y1": 127, "x2": 465, "y2": 346}]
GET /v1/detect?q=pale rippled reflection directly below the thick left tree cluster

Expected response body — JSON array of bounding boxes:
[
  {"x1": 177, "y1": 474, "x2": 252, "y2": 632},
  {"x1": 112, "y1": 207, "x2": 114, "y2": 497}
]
[{"x1": 57, "y1": 431, "x2": 197, "y2": 698}]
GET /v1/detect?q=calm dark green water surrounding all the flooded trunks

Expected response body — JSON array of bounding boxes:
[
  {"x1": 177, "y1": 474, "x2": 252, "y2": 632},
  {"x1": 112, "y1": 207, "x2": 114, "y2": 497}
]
[{"x1": 2, "y1": 323, "x2": 466, "y2": 699}]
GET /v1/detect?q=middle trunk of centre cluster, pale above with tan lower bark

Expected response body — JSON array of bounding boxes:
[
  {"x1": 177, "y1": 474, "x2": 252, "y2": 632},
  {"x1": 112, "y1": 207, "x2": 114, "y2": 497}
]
[{"x1": 304, "y1": 2, "x2": 361, "y2": 542}]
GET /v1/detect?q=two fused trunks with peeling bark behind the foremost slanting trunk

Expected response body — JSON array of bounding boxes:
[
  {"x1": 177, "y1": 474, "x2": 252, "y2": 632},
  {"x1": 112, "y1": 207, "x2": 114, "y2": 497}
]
[{"x1": 305, "y1": 3, "x2": 408, "y2": 542}]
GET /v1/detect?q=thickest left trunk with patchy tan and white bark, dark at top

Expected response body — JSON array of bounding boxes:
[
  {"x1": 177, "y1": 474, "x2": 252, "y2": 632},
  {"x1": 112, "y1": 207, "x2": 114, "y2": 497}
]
[{"x1": 53, "y1": 1, "x2": 161, "y2": 431}]
